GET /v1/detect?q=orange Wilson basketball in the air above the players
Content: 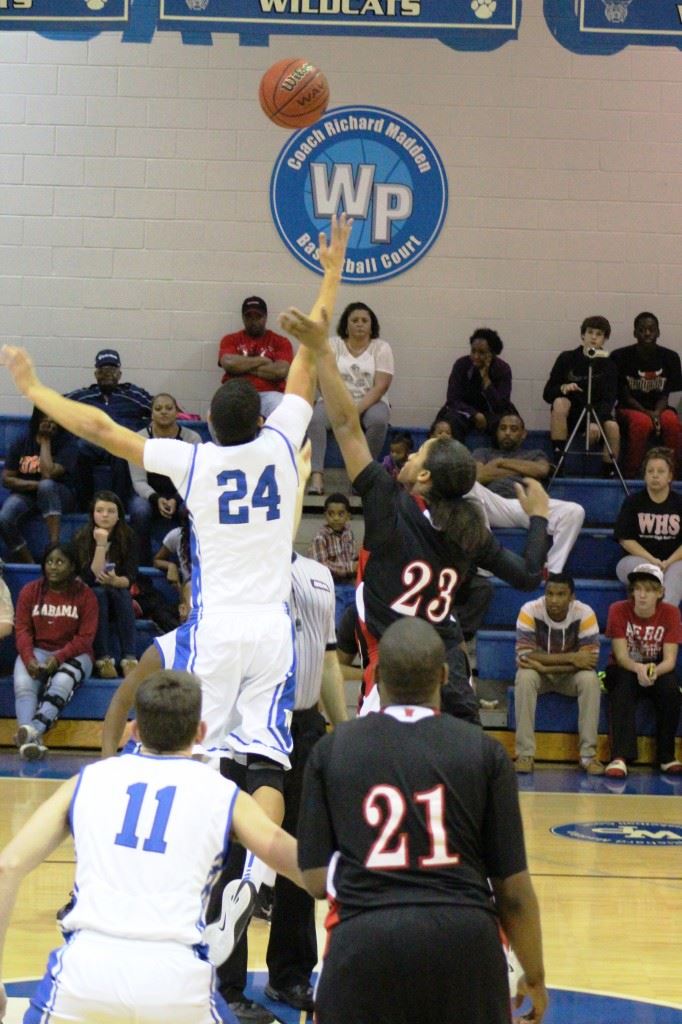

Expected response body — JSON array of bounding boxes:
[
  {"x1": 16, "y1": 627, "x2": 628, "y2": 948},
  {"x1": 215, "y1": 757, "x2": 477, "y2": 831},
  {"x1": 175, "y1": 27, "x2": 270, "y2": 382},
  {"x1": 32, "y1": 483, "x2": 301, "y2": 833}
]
[{"x1": 258, "y1": 57, "x2": 329, "y2": 128}]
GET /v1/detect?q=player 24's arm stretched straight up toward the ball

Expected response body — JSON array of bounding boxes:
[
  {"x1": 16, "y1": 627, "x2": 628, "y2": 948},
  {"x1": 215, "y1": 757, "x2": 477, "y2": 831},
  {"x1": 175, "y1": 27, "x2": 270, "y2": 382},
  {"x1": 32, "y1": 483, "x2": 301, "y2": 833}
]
[{"x1": 280, "y1": 213, "x2": 352, "y2": 404}]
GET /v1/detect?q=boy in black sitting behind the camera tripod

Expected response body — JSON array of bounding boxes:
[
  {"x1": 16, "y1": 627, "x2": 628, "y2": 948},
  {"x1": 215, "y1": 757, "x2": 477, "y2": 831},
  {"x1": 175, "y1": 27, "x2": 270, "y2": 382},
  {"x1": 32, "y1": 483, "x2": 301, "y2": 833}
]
[{"x1": 543, "y1": 316, "x2": 621, "y2": 478}]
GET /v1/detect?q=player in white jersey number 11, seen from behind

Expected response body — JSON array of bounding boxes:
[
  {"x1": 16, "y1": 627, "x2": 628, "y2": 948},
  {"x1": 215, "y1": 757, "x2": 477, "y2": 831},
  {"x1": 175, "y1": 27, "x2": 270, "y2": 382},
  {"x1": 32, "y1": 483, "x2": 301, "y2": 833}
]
[{"x1": 0, "y1": 671, "x2": 301, "y2": 1024}]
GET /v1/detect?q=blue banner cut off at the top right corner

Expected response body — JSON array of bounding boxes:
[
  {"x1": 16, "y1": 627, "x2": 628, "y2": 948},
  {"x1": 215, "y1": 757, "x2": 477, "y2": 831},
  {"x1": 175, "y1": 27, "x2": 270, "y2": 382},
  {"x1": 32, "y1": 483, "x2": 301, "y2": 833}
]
[{"x1": 545, "y1": 0, "x2": 682, "y2": 54}]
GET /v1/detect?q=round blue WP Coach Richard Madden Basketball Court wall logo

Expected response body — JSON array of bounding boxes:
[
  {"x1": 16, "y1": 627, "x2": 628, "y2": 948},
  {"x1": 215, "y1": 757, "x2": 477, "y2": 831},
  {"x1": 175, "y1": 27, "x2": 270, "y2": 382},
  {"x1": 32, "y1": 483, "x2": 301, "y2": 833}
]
[{"x1": 270, "y1": 106, "x2": 447, "y2": 284}]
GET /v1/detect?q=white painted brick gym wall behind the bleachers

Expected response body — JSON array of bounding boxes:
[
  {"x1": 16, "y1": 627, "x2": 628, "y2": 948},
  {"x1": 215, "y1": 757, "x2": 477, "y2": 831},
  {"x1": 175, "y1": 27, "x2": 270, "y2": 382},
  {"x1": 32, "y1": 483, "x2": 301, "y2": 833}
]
[{"x1": 0, "y1": 0, "x2": 682, "y2": 426}]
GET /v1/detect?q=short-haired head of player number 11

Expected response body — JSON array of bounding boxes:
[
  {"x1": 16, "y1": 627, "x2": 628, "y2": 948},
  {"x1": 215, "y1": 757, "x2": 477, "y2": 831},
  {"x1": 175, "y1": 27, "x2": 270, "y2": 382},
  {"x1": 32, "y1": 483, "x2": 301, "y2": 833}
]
[{"x1": 135, "y1": 670, "x2": 202, "y2": 754}]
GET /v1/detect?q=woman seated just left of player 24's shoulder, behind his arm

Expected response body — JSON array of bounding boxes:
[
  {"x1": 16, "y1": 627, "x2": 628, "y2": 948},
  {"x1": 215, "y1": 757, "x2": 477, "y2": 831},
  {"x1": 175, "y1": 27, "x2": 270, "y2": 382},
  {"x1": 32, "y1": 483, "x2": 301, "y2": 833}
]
[{"x1": 128, "y1": 391, "x2": 202, "y2": 565}]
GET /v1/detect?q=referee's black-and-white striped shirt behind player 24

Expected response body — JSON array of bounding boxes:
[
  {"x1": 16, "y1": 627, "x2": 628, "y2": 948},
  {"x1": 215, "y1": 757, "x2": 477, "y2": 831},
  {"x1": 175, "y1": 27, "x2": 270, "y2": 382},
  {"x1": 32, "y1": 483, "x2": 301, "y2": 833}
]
[{"x1": 291, "y1": 554, "x2": 336, "y2": 711}]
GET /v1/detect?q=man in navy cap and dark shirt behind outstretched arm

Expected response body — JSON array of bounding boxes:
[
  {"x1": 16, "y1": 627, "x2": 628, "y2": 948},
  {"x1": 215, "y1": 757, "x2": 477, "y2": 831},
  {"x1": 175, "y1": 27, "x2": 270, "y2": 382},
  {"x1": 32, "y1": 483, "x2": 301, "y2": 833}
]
[{"x1": 67, "y1": 348, "x2": 152, "y2": 509}]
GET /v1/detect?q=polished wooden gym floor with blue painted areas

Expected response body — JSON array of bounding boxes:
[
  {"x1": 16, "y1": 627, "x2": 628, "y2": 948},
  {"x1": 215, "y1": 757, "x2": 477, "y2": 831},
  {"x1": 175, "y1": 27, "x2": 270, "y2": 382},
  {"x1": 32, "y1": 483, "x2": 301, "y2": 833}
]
[{"x1": 0, "y1": 752, "x2": 682, "y2": 1024}]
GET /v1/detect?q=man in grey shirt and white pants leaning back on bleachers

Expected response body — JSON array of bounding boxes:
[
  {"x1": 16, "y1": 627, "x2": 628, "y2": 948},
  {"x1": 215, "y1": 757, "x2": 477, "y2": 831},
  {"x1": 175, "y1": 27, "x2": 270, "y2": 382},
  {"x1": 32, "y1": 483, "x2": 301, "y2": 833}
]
[{"x1": 450, "y1": 413, "x2": 585, "y2": 572}]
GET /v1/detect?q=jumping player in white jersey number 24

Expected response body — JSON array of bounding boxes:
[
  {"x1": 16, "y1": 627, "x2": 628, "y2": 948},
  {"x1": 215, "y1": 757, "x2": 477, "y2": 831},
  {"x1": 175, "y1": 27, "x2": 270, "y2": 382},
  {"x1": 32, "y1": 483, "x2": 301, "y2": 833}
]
[{"x1": 2, "y1": 215, "x2": 351, "y2": 839}]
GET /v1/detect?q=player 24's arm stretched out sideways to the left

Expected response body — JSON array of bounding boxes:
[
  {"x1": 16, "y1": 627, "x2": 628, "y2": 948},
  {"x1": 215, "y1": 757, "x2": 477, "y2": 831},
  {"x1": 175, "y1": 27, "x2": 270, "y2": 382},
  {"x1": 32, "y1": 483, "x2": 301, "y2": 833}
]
[{"x1": 0, "y1": 345, "x2": 144, "y2": 466}]
